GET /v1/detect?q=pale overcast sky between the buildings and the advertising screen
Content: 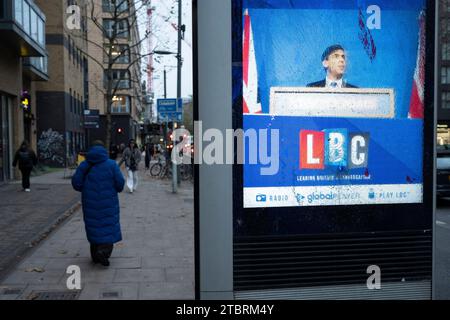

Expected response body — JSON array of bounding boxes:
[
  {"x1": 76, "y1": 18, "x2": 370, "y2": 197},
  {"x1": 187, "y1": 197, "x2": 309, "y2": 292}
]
[{"x1": 136, "y1": 0, "x2": 192, "y2": 99}]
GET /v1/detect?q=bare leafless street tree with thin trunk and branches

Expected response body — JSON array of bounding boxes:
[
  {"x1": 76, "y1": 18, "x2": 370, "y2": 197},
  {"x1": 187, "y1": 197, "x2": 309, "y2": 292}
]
[{"x1": 67, "y1": 0, "x2": 165, "y2": 149}]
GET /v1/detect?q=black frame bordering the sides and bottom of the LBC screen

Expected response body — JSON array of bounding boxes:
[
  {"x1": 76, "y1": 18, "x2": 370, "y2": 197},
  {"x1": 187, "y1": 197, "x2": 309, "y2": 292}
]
[{"x1": 232, "y1": 0, "x2": 436, "y2": 239}]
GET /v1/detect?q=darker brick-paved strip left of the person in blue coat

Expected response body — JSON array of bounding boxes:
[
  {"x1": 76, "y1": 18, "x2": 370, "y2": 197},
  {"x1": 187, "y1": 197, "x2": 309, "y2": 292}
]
[{"x1": 0, "y1": 170, "x2": 80, "y2": 281}]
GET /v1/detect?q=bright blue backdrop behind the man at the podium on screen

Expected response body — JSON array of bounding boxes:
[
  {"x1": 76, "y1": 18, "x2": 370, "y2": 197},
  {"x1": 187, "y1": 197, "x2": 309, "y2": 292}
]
[{"x1": 244, "y1": 0, "x2": 425, "y2": 118}]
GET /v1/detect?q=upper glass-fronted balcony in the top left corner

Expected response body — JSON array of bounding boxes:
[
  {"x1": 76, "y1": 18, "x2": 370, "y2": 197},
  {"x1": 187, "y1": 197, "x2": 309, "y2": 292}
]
[{"x1": 0, "y1": 0, "x2": 46, "y2": 57}]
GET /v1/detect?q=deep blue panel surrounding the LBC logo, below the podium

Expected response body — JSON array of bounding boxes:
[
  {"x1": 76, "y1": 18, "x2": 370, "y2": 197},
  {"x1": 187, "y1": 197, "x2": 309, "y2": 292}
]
[{"x1": 244, "y1": 115, "x2": 423, "y2": 188}]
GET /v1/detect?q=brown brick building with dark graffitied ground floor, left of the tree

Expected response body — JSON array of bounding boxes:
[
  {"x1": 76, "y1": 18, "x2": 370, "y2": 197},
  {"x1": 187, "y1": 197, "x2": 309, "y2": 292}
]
[{"x1": 36, "y1": 0, "x2": 88, "y2": 167}]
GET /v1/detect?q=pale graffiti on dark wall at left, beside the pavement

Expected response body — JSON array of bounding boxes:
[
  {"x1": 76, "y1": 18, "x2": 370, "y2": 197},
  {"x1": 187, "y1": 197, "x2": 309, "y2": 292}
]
[{"x1": 38, "y1": 128, "x2": 64, "y2": 165}]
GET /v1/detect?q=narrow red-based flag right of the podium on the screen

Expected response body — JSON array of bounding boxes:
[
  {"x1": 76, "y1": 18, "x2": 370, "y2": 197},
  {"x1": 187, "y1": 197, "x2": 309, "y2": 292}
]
[{"x1": 408, "y1": 11, "x2": 425, "y2": 119}]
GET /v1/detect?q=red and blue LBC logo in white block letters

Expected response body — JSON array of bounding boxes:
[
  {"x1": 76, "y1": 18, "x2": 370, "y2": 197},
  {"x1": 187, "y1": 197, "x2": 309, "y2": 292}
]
[{"x1": 300, "y1": 129, "x2": 370, "y2": 170}]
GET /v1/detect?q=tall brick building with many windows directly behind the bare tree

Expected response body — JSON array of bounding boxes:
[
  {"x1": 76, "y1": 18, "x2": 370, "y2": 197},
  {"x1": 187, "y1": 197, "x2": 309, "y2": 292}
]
[{"x1": 83, "y1": 0, "x2": 143, "y2": 145}]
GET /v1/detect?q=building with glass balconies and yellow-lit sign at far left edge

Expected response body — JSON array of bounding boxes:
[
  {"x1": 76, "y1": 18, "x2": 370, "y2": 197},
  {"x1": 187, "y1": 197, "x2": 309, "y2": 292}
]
[{"x1": 0, "y1": 0, "x2": 48, "y2": 183}]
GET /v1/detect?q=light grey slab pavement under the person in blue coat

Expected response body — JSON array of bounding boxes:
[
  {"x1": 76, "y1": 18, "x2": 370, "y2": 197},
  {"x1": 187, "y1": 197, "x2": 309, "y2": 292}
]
[{"x1": 0, "y1": 170, "x2": 194, "y2": 299}]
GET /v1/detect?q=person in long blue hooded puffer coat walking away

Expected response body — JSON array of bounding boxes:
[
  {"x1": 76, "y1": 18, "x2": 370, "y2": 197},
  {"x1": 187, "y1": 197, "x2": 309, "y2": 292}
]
[{"x1": 72, "y1": 141, "x2": 125, "y2": 266}]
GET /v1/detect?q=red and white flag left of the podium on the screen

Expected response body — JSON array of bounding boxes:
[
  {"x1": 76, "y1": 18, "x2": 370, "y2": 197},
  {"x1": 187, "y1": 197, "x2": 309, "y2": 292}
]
[{"x1": 242, "y1": 10, "x2": 261, "y2": 113}]
